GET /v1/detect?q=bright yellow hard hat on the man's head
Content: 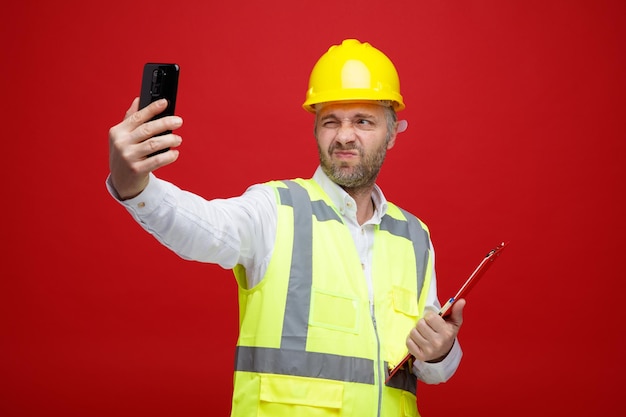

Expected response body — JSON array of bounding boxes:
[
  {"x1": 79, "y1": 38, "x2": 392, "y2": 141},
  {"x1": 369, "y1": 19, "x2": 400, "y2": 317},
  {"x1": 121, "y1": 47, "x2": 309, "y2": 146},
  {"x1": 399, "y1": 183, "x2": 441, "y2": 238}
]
[{"x1": 302, "y1": 39, "x2": 404, "y2": 113}]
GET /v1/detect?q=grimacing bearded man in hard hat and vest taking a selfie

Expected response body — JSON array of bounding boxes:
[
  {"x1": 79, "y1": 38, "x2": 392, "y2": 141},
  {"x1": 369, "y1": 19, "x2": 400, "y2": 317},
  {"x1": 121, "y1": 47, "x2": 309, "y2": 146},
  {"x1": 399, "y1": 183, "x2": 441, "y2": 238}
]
[{"x1": 107, "y1": 39, "x2": 465, "y2": 416}]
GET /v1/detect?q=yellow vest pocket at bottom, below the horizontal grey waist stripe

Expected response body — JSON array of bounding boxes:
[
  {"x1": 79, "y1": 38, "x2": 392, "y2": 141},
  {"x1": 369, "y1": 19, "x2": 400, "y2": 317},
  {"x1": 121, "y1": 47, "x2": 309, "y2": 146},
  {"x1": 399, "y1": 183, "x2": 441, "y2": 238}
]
[{"x1": 258, "y1": 374, "x2": 343, "y2": 417}]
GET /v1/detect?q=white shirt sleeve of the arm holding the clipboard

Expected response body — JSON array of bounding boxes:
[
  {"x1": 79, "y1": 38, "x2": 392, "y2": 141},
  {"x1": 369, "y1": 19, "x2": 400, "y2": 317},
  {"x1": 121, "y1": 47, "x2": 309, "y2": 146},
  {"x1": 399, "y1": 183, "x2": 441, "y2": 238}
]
[{"x1": 413, "y1": 237, "x2": 463, "y2": 384}]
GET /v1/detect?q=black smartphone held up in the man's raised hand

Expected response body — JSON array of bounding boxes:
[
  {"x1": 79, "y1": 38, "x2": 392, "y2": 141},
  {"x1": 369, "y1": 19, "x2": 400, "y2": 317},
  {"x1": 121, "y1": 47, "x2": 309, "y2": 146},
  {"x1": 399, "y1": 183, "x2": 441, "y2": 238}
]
[{"x1": 139, "y1": 62, "x2": 180, "y2": 157}]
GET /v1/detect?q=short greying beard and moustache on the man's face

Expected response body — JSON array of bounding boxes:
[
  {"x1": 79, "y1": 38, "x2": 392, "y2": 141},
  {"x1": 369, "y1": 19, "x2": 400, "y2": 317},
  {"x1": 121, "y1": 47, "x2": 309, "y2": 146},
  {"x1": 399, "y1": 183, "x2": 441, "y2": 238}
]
[{"x1": 317, "y1": 142, "x2": 387, "y2": 189}]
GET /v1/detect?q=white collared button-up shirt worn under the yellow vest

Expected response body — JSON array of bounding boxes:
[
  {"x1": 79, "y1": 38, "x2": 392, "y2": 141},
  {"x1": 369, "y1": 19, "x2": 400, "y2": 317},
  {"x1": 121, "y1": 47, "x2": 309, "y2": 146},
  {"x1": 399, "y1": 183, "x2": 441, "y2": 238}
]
[{"x1": 107, "y1": 167, "x2": 463, "y2": 384}]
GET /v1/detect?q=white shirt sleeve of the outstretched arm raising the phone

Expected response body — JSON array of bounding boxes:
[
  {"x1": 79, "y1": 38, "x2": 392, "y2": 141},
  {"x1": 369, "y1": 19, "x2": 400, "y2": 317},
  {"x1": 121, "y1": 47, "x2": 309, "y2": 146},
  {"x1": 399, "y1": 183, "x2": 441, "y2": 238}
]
[{"x1": 106, "y1": 174, "x2": 277, "y2": 280}]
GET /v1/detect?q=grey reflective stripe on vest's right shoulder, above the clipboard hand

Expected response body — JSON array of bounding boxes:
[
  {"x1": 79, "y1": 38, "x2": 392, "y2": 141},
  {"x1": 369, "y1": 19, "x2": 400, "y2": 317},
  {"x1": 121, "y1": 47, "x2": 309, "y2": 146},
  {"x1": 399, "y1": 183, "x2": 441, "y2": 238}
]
[{"x1": 380, "y1": 208, "x2": 430, "y2": 300}]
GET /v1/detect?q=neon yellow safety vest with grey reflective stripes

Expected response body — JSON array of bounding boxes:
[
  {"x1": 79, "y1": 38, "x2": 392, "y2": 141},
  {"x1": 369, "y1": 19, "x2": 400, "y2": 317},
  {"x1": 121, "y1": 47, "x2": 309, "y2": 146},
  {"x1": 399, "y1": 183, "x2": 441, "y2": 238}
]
[{"x1": 231, "y1": 179, "x2": 432, "y2": 417}]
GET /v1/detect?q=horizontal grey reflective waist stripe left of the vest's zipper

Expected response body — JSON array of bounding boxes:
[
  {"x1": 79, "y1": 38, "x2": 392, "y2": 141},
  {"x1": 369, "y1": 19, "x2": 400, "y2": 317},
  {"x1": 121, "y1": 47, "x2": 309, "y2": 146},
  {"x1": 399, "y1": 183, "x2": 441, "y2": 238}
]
[{"x1": 235, "y1": 346, "x2": 374, "y2": 385}]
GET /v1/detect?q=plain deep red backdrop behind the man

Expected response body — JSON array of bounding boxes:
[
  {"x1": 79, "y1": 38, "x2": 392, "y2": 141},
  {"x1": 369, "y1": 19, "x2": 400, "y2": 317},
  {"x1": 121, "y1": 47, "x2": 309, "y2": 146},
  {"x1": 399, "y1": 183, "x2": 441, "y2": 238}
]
[{"x1": 0, "y1": 0, "x2": 626, "y2": 417}]
